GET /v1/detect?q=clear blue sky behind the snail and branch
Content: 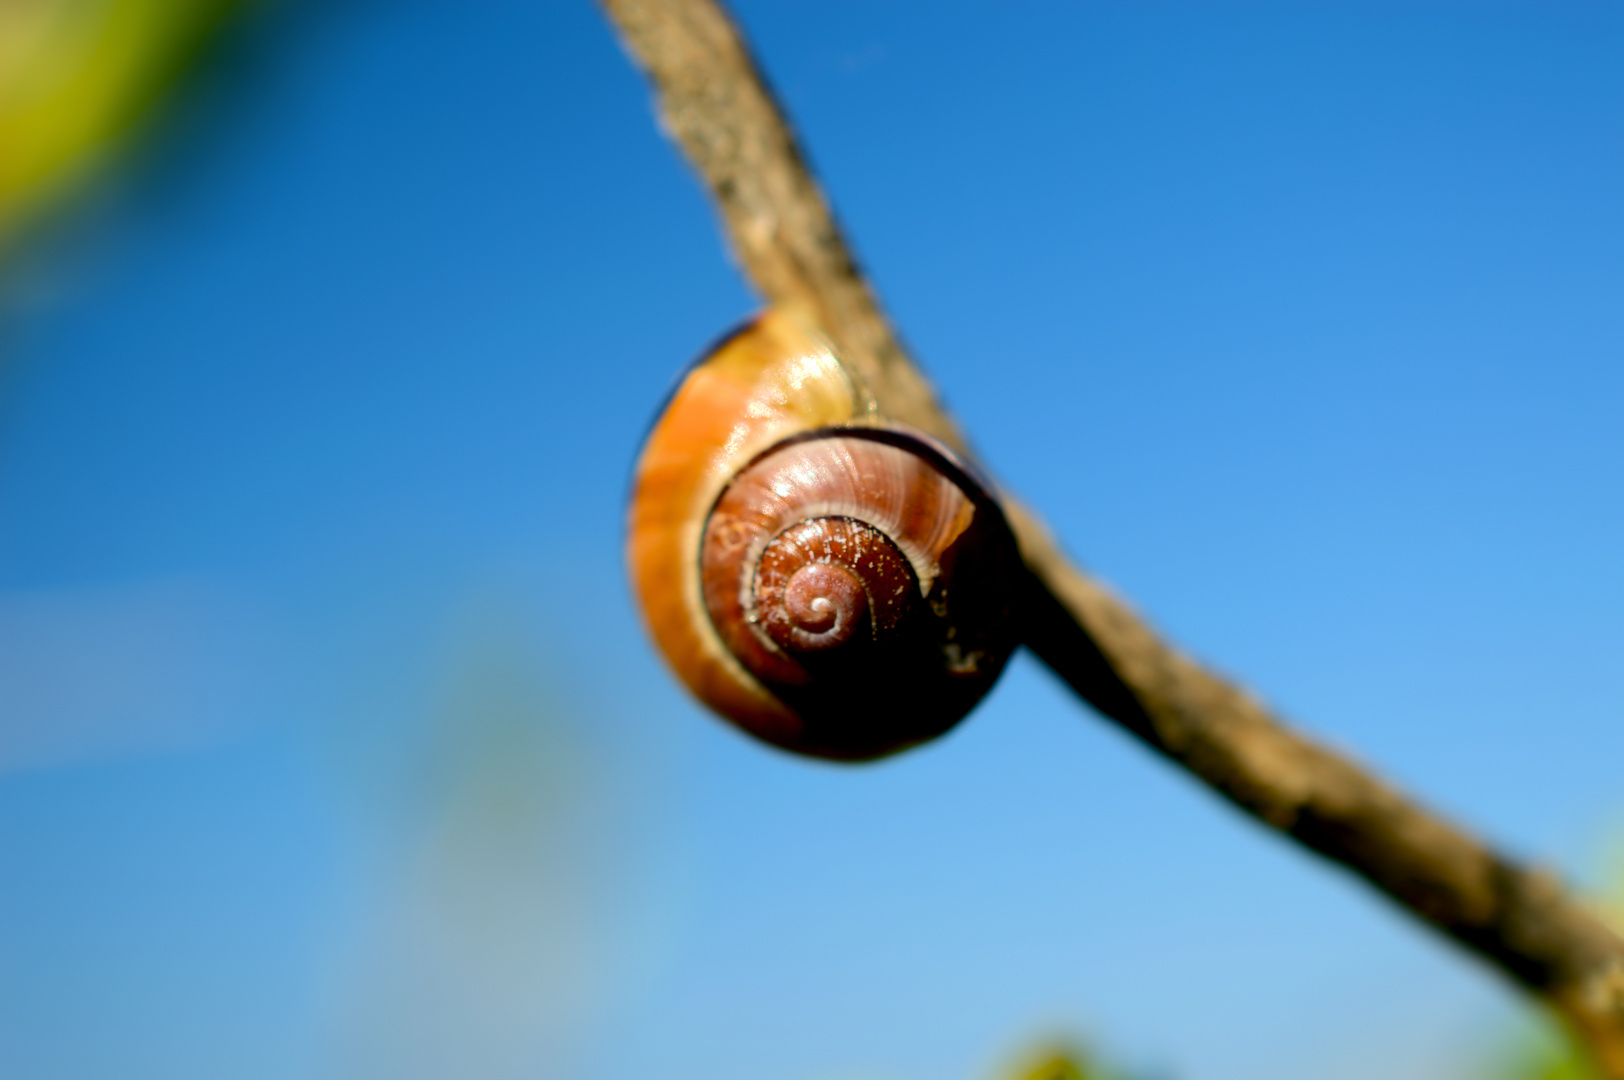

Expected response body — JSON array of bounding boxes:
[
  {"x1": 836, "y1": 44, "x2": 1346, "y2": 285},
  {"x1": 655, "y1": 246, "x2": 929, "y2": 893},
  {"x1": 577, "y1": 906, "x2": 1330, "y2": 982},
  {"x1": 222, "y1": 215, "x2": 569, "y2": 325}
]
[{"x1": 0, "y1": 0, "x2": 1624, "y2": 1080}]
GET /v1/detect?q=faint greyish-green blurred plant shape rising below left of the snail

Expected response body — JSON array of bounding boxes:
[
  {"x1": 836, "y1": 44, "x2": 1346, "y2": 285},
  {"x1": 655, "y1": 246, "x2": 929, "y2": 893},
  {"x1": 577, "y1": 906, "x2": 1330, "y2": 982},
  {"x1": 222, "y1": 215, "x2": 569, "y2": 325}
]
[{"x1": 336, "y1": 594, "x2": 626, "y2": 1080}]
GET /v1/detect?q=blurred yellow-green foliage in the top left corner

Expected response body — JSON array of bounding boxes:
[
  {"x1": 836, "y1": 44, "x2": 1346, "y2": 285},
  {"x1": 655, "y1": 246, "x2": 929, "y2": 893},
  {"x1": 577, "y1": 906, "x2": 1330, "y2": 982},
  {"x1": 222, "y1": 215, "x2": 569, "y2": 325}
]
[{"x1": 0, "y1": 0, "x2": 265, "y2": 257}]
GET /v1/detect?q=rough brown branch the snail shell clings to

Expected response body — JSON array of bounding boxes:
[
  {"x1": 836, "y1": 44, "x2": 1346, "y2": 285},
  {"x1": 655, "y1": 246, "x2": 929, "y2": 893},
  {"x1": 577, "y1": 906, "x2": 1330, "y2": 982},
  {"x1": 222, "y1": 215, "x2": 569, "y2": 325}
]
[{"x1": 599, "y1": 0, "x2": 1624, "y2": 1080}]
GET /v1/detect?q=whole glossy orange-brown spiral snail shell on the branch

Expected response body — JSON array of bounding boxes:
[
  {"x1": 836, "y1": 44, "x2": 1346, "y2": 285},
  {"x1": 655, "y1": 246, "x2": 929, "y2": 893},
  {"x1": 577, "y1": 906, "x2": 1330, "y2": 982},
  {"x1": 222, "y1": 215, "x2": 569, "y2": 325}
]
[{"x1": 628, "y1": 312, "x2": 1018, "y2": 760}]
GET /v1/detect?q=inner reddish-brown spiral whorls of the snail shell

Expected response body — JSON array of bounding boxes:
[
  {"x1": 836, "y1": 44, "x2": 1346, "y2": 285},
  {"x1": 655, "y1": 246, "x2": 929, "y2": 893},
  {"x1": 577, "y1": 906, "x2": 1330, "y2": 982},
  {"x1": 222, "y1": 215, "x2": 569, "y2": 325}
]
[{"x1": 700, "y1": 427, "x2": 1012, "y2": 744}]
